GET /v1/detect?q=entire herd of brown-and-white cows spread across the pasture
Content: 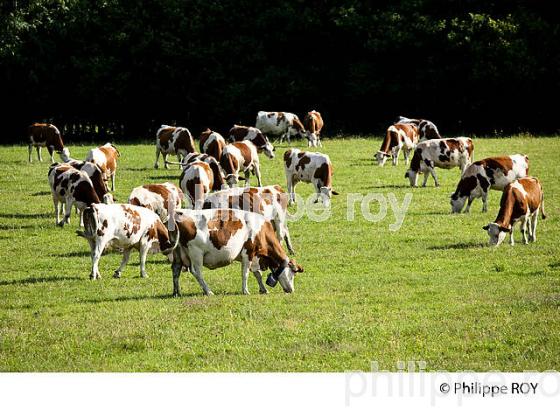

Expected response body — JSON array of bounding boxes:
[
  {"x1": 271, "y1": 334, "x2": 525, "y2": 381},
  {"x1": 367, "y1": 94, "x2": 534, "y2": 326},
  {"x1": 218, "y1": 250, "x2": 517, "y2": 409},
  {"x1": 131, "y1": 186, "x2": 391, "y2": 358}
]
[{"x1": 29, "y1": 111, "x2": 546, "y2": 296}]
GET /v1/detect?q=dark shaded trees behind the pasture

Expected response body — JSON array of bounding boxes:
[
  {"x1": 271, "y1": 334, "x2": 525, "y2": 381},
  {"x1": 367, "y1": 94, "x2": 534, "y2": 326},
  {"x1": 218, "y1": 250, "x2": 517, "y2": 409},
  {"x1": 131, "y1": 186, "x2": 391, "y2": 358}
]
[{"x1": 0, "y1": 0, "x2": 560, "y2": 143}]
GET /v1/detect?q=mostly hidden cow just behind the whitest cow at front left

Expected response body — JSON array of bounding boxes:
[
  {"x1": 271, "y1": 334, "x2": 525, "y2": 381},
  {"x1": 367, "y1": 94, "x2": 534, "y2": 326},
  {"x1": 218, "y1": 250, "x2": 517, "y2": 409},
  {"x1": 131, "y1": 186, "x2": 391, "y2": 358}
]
[{"x1": 128, "y1": 182, "x2": 183, "y2": 223}]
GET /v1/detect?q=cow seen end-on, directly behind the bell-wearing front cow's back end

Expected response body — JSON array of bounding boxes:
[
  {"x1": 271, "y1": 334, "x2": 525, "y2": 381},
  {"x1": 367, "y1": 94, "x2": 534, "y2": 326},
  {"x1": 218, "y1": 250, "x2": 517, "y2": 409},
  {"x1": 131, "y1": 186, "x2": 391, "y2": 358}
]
[{"x1": 179, "y1": 161, "x2": 214, "y2": 209}]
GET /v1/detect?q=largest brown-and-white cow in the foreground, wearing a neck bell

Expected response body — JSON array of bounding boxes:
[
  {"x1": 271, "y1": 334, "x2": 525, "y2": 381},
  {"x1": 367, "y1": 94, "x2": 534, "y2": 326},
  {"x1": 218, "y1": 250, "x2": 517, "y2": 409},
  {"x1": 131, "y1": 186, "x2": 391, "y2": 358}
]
[{"x1": 170, "y1": 209, "x2": 303, "y2": 296}]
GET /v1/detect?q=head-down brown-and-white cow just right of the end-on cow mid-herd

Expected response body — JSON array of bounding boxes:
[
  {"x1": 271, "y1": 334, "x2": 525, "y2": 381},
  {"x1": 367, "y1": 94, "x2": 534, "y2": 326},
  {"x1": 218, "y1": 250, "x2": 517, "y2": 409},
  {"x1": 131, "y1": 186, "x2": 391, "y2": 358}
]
[{"x1": 220, "y1": 141, "x2": 262, "y2": 188}]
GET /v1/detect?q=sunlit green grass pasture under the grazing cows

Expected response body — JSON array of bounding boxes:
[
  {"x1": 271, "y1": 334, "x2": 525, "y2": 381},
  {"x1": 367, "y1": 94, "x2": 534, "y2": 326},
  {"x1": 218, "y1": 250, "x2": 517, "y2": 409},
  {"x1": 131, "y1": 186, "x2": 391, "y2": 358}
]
[{"x1": 0, "y1": 137, "x2": 560, "y2": 371}]
